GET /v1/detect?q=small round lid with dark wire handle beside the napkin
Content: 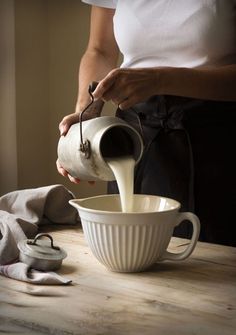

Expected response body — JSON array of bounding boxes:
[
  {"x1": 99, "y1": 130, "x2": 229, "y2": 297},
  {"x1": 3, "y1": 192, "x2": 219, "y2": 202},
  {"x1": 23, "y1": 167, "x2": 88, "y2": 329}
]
[{"x1": 18, "y1": 233, "x2": 67, "y2": 261}]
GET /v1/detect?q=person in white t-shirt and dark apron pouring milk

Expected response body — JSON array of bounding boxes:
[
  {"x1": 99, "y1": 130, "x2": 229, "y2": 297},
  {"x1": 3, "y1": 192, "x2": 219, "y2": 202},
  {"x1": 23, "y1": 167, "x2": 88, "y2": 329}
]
[{"x1": 57, "y1": 0, "x2": 236, "y2": 246}]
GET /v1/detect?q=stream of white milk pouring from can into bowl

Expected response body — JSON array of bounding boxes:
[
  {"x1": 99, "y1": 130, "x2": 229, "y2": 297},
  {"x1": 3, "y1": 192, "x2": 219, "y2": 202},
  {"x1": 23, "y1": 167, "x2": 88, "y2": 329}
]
[{"x1": 106, "y1": 156, "x2": 135, "y2": 212}]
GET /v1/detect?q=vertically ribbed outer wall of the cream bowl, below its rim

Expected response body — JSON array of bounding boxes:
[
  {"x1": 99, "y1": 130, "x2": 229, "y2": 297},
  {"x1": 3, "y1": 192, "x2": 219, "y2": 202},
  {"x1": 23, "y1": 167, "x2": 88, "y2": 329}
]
[{"x1": 81, "y1": 219, "x2": 172, "y2": 272}]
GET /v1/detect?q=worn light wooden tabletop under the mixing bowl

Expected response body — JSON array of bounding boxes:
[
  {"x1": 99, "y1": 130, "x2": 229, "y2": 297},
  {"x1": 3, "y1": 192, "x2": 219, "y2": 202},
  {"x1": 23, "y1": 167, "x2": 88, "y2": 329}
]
[{"x1": 0, "y1": 226, "x2": 236, "y2": 335}]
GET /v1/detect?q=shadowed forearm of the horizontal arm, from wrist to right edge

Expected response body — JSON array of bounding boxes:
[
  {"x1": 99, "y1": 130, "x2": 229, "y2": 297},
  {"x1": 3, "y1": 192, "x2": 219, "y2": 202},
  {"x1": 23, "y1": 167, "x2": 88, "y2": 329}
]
[{"x1": 161, "y1": 65, "x2": 236, "y2": 101}]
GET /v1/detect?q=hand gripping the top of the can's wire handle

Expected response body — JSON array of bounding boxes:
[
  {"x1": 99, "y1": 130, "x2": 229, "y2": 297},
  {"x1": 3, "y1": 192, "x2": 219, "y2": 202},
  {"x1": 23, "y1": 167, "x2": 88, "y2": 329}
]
[{"x1": 93, "y1": 68, "x2": 163, "y2": 109}]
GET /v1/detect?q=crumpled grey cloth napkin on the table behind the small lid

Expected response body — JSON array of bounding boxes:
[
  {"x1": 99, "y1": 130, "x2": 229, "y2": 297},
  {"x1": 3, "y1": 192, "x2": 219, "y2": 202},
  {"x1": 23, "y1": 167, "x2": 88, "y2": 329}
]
[{"x1": 0, "y1": 185, "x2": 78, "y2": 284}]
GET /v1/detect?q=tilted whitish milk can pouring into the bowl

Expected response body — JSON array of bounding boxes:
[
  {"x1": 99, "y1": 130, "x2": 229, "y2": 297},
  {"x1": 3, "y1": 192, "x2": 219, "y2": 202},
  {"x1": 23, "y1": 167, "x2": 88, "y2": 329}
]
[{"x1": 57, "y1": 116, "x2": 143, "y2": 181}]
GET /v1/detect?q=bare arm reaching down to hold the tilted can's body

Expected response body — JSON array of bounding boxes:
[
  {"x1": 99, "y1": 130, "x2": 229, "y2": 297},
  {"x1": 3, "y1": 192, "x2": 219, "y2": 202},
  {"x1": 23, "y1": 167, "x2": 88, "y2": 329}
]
[{"x1": 59, "y1": 6, "x2": 119, "y2": 135}]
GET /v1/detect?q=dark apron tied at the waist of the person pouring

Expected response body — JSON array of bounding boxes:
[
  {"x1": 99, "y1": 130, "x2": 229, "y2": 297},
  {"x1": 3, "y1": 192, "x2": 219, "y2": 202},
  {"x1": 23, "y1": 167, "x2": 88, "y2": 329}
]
[{"x1": 108, "y1": 96, "x2": 236, "y2": 246}]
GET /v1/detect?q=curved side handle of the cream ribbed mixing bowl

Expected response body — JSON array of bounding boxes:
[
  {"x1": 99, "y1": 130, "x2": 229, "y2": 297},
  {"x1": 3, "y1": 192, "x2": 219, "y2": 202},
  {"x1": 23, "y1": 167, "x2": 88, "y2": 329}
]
[{"x1": 161, "y1": 212, "x2": 200, "y2": 261}]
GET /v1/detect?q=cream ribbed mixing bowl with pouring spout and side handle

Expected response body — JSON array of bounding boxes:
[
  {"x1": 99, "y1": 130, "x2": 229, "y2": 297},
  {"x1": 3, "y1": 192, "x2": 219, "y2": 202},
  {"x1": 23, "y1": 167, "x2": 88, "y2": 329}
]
[{"x1": 69, "y1": 195, "x2": 200, "y2": 272}]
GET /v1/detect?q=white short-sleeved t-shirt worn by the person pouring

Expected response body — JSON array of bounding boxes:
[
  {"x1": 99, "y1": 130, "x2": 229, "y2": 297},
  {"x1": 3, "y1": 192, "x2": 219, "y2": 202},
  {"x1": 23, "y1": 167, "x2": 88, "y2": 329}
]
[{"x1": 82, "y1": 0, "x2": 236, "y2": 68}]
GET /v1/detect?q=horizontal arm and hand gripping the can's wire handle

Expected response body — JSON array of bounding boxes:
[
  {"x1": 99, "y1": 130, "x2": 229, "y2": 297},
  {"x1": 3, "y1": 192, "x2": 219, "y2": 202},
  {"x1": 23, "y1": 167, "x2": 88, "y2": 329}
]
[{"x1": 91, "y1": 64, "x2": 236, "y2": 109}]
